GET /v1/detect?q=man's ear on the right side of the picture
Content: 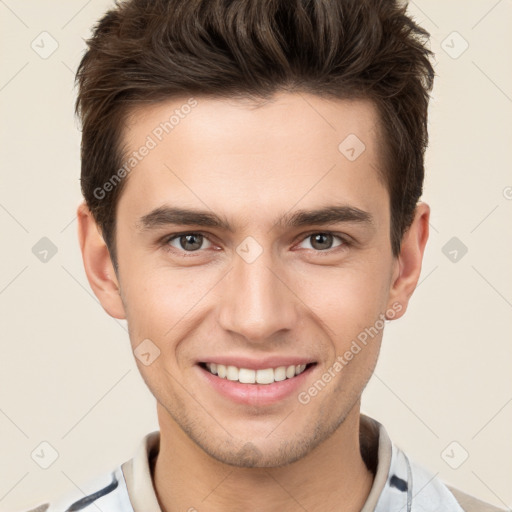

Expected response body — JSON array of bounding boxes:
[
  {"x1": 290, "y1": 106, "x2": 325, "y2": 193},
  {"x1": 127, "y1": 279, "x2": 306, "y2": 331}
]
[{"x1": 388, "y1": 203, "x2": 430, "y2": 319}]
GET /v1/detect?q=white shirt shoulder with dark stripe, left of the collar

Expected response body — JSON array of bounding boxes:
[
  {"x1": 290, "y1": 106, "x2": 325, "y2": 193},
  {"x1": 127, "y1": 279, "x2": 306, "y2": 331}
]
[{"x1": 19, "y1": 466, "x2": 133, "y2": 512}]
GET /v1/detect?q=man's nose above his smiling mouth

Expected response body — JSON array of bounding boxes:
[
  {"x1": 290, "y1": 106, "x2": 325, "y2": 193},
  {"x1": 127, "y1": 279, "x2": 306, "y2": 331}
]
[{"x1": 219, "y1": 252, "x2": 300, "y2": 343}]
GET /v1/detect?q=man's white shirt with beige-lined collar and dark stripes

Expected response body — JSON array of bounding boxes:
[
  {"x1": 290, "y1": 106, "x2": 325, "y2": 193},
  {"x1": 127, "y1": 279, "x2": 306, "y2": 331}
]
[{"x1": 27, "y1": 414, "x2": 500, "y2": 512}]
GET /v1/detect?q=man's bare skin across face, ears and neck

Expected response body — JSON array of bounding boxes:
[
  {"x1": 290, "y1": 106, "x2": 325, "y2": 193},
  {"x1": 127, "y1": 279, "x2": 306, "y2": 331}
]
[{"x1": 78, "y1": 93, "x2": 429, "y2": 512}]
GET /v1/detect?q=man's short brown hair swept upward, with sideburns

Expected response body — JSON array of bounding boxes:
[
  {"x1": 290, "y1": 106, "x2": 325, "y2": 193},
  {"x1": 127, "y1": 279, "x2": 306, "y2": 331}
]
[{"x1": 76, "y1": 0, "x2": 434, "y2": 268}]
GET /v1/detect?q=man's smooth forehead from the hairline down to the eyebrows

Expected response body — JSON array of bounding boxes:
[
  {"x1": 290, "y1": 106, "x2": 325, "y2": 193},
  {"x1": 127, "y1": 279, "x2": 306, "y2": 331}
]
[{"x1": 120, "y1": 93, "x2": 387, "y2": 228}]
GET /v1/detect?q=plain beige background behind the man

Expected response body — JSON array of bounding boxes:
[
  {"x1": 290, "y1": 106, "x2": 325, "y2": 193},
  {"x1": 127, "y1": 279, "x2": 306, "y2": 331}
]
[{"x1": 0, "y1": 0, "x2": 512, "y2": 511}]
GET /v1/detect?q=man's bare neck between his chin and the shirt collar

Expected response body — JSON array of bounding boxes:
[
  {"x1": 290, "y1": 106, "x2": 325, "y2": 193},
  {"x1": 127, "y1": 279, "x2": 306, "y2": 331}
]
[{"x1": 153, "y1": 402, "x2": 374, "y2": 512}]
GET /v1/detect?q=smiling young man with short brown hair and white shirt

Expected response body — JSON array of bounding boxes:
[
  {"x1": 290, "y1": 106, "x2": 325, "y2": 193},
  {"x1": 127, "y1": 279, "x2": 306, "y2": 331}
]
[{"x1": 24, "y1": 0, "x2": 504, "y2": 512}]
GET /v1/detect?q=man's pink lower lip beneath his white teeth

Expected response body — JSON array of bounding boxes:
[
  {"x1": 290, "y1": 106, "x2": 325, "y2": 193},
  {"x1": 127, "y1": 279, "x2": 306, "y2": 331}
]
[{"x1": 197, "y1": 365, "x2": 315, "y2": 405}]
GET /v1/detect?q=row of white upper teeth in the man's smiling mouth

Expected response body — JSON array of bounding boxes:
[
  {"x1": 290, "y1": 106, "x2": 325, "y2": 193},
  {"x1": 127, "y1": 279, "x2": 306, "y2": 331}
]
[{"x1": 199, "y1": 363, "x2": 316, "y2": 384}]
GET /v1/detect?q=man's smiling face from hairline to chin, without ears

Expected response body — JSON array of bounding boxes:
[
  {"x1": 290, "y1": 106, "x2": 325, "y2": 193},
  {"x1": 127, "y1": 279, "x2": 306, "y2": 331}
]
[{"x1": 116, "y1": 94, "x2": 397, "y2": 466}]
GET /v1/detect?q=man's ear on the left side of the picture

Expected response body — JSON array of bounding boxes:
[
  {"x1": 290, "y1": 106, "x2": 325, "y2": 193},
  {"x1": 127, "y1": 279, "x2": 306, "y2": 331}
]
[{"x1": 77, "y1": 202, "x2": 126, "y2": 319}]
